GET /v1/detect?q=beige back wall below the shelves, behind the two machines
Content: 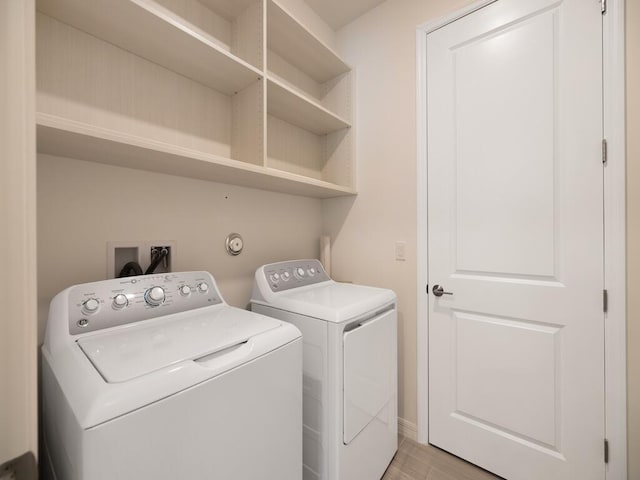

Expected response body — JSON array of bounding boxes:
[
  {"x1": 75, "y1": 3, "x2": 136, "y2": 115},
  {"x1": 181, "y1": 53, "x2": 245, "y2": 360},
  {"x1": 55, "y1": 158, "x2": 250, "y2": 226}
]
[{"x1": 38, "y1": 155, "x2": 322, "y2": 341}]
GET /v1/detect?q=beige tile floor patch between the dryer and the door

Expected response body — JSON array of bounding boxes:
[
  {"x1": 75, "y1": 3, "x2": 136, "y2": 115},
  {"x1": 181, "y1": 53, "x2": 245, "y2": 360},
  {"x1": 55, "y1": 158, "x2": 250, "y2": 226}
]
[{"x1": 382, "y1": 437, "x2": 500, "y2": 480}]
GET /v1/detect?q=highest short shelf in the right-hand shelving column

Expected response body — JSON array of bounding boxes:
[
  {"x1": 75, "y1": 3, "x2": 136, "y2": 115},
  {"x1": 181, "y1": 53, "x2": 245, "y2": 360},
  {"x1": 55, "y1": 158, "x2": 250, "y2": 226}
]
[{"x1": 267, "y1": 0, "x2": 350, "y2": 83}]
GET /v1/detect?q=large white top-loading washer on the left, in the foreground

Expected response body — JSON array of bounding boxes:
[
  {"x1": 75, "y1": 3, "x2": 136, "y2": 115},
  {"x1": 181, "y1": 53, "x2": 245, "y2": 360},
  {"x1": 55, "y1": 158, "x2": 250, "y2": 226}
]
[{"x1": 42, "y1": 272, "x2": 302, "y2": 480}]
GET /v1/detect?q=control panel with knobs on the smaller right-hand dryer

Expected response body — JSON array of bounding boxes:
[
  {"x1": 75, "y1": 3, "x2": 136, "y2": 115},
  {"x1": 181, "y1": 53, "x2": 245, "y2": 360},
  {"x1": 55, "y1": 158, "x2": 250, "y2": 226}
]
[{"x1": 264, "y1": 260, "x2": 331, "y2": 292}]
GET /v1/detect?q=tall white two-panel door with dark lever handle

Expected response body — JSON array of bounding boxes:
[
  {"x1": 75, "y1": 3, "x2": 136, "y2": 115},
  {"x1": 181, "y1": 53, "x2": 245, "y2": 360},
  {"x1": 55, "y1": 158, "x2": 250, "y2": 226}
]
[{"x1": 427, "y1": 0, "x2": 605, "y2": 480}]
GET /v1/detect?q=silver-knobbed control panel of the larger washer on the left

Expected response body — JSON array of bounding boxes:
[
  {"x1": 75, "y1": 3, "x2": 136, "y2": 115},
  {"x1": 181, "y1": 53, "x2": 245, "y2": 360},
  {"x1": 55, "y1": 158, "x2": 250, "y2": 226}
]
[{"x1": 68, "y1": 272, "x2": 223, "y2": 335}]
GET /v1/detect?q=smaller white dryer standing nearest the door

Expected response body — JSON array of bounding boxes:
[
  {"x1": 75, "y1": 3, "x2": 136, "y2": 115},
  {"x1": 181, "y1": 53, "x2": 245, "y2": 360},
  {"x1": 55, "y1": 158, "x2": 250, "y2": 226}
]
[{"x1": 251, "y1": 260, "x2": 398, "y2": 480}]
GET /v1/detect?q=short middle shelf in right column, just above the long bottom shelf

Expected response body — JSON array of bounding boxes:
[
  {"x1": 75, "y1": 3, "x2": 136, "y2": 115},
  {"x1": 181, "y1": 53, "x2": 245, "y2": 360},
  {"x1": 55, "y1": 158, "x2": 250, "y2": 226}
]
[{"x1": 267, "y1": 78, "x2": 351, "y2": 135}]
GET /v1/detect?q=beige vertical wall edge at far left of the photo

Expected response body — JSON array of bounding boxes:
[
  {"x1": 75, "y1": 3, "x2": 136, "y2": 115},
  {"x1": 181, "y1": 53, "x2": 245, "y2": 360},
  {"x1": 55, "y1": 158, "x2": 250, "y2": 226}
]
[{"x1": 0, "y1": 0, "x2": 38, "y2": 465}]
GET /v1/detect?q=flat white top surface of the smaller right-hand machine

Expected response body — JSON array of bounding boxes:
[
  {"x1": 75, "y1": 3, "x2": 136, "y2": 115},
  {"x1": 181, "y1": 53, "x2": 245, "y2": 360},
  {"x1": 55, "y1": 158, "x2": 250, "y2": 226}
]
[{"x1": 268, "y1": 281, "x2": 396, "y2": 323}]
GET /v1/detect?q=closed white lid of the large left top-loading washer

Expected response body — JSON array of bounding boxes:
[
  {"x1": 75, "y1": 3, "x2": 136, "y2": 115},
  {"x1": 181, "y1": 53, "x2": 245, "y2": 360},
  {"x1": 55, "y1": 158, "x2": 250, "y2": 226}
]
[{"x1": 78, "y1": 306, "x2": 281, "y2": 383}]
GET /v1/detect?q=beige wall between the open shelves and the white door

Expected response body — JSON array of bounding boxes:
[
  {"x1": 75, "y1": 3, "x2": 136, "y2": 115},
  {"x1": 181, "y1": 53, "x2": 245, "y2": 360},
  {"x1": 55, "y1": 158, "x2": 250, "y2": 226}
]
[{"x1": 323, "y1": 0, "x2": 478, "y2": 433}]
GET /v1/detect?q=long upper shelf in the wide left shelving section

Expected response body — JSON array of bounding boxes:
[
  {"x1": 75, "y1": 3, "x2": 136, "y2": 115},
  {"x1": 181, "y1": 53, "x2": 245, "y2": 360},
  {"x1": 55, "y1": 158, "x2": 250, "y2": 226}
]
[{"x1": 38, "y1": 0, "x2": 262, "y2": 95}]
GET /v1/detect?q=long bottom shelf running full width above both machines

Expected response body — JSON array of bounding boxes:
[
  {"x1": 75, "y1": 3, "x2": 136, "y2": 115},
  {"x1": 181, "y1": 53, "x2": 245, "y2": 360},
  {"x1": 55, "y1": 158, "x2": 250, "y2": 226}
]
[{"x1": 36, "y1": 113, "x2": 356, "y2": 198}]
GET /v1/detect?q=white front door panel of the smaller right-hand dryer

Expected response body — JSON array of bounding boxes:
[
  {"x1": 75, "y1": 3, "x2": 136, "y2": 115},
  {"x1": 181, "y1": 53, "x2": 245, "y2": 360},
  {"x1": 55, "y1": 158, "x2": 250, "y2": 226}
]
[{"x1": 343, "y1": 308, "x2": 397, "y2": 444}]
